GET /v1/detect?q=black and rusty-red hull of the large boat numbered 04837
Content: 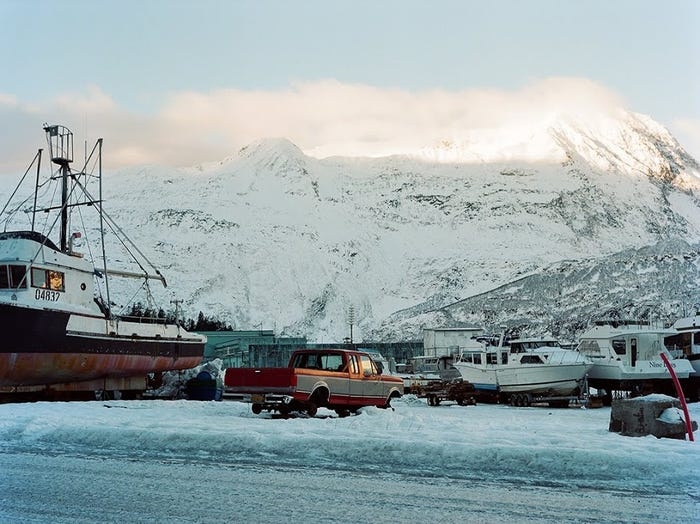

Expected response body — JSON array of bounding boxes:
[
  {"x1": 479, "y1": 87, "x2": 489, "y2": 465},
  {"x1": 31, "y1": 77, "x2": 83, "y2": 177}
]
[{"x1": 0, "y1": 305, "x2": 204, "y2": 387}]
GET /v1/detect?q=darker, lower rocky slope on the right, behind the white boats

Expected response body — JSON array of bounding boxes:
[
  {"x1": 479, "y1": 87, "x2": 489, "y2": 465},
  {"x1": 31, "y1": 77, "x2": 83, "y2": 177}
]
[{"x1": 377, "y1": 240, "x2": 700, "y2": 343}]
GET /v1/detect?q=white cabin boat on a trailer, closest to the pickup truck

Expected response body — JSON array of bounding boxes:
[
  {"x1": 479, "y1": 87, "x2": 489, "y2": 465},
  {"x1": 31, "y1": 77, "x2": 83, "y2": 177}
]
[{"x1": 452, "y1": 333, "x2": 591, "y2": 405}]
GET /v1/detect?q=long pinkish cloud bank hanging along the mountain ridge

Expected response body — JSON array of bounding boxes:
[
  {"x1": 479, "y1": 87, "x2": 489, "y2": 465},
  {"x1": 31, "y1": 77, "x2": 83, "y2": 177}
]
[{"x1": 0, "y1": 78, "x2": 636, "y2": 172}]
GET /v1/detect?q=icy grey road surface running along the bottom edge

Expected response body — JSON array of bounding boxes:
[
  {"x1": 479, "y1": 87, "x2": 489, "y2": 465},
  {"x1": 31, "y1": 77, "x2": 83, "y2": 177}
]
[{"x1": 0, "y1": 454, "x2": 690, "y2": 524}]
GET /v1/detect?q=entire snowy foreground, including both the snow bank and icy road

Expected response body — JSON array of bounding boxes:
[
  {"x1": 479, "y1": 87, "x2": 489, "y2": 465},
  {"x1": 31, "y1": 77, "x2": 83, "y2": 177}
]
[{"x1": 0, "y1": 396, "x2": 700, "y2": 523}]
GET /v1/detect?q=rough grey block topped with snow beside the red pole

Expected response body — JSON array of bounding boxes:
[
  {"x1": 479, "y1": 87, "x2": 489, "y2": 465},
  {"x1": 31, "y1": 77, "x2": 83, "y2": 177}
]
[{"x1": 608, "y1": 394, "x2": 698, "y2": 440}]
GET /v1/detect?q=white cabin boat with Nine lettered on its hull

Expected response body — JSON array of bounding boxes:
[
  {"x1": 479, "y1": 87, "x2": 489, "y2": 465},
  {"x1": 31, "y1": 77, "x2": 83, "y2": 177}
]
[{"x1": 577, "y1": 319, "x2": 693, "y2": 395}]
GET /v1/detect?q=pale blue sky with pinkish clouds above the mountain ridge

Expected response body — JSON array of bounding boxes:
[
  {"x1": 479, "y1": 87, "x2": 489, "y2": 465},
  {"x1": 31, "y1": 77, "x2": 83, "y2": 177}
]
[{"x1": 0, "y1": 0, "x2": 700, "y2": 173}]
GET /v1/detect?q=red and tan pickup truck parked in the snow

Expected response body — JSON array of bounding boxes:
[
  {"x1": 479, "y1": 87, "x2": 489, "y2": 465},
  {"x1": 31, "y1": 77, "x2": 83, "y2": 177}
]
[{"x1": 224, "y1": 349, "x2": 404, "y2": 417}]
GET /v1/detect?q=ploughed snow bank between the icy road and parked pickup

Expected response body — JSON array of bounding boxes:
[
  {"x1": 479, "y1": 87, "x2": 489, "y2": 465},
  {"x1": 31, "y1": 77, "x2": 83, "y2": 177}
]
[{"x1": 0, "y1": 395, "x2": 700, "y2": 498}]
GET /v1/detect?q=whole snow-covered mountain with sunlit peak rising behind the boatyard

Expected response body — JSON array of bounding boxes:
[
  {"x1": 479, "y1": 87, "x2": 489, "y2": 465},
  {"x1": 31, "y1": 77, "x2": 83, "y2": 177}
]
[{"x1": 6, "y1": 108, "x2": 700, "y2": 342}]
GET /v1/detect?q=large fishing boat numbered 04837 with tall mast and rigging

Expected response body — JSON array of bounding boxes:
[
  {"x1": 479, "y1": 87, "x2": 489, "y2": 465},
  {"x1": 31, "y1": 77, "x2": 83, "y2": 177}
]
[{"x1": 0, "y1": 125, "x2": 206, "y2": 398}]
